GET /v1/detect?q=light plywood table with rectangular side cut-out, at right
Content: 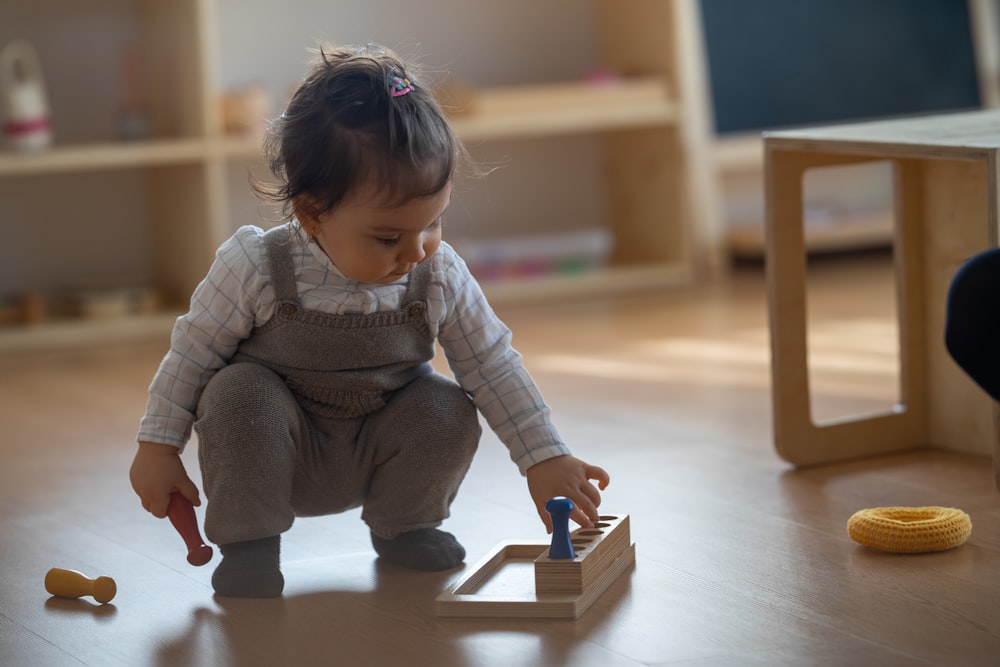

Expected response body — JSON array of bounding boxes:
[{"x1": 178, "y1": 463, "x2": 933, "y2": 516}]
[{"x1": 764, "y1": 111, "x2": 1000, "y2": 487}]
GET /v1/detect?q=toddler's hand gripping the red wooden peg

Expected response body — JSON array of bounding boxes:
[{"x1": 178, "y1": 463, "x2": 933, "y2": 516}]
[{"x1": 129, "y1": 442, "x2": 201, "y2": 519}]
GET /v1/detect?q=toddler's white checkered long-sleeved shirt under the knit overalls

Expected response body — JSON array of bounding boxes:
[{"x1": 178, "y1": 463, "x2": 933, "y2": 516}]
[{"x1": 138, "y1": 223, "x2": 569, "y2": 473}]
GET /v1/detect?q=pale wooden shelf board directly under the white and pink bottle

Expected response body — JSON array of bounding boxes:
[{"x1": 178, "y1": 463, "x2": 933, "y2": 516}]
[{"x1": 0, "y1": 139, "x2": 205, "y2": 176}]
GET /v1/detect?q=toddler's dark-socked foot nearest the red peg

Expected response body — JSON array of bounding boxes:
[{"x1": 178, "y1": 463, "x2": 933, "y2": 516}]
[{"x1": 212, "y1": 535, "x2": 285, "y2": 598}]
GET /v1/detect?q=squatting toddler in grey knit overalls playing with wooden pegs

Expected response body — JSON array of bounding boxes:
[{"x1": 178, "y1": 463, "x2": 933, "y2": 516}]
[{"x1": 130, "y1": 46, "x2": 609, "y2": 597}]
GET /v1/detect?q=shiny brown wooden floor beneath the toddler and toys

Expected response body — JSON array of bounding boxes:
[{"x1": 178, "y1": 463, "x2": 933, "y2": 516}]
[{"x1": 0, "y1": 252, "x2": 1000, "y2": 667}]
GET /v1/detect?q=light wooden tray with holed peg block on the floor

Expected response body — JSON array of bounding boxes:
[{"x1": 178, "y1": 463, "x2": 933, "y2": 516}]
[{"x1": 436, "y1": 514, "x2": 635, "y2": 619}]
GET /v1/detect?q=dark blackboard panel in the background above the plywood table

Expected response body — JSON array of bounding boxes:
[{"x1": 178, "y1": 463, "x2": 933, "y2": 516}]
[{"x1": 701, "y1": 0, "x2": 981, "y2": 134}]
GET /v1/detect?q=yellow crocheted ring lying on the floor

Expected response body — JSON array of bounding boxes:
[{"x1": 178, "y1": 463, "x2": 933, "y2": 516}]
[{"x1": 847, "y1": 507, "x2": 972, "y2": 554}]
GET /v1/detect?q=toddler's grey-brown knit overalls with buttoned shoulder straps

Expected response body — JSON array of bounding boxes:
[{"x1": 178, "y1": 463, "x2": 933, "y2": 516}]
[{"x1": 195, "y1": 226, "x2": 481, "y2": 544}]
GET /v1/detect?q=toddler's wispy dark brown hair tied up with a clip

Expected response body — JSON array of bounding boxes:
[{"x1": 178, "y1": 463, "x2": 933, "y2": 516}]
[{"x1": 252, "y1": 44, "x2": 465, "y2": 218}]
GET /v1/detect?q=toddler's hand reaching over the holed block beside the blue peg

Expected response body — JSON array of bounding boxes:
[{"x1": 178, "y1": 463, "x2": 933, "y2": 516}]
[{"x1": 528, "y1": 455, "x2": 611, "y2": 533}]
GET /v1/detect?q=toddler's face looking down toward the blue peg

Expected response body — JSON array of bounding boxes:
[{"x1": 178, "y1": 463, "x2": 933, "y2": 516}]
[{"x1": 306, "y1": 183, "x2": 451, "y2": 285}]
